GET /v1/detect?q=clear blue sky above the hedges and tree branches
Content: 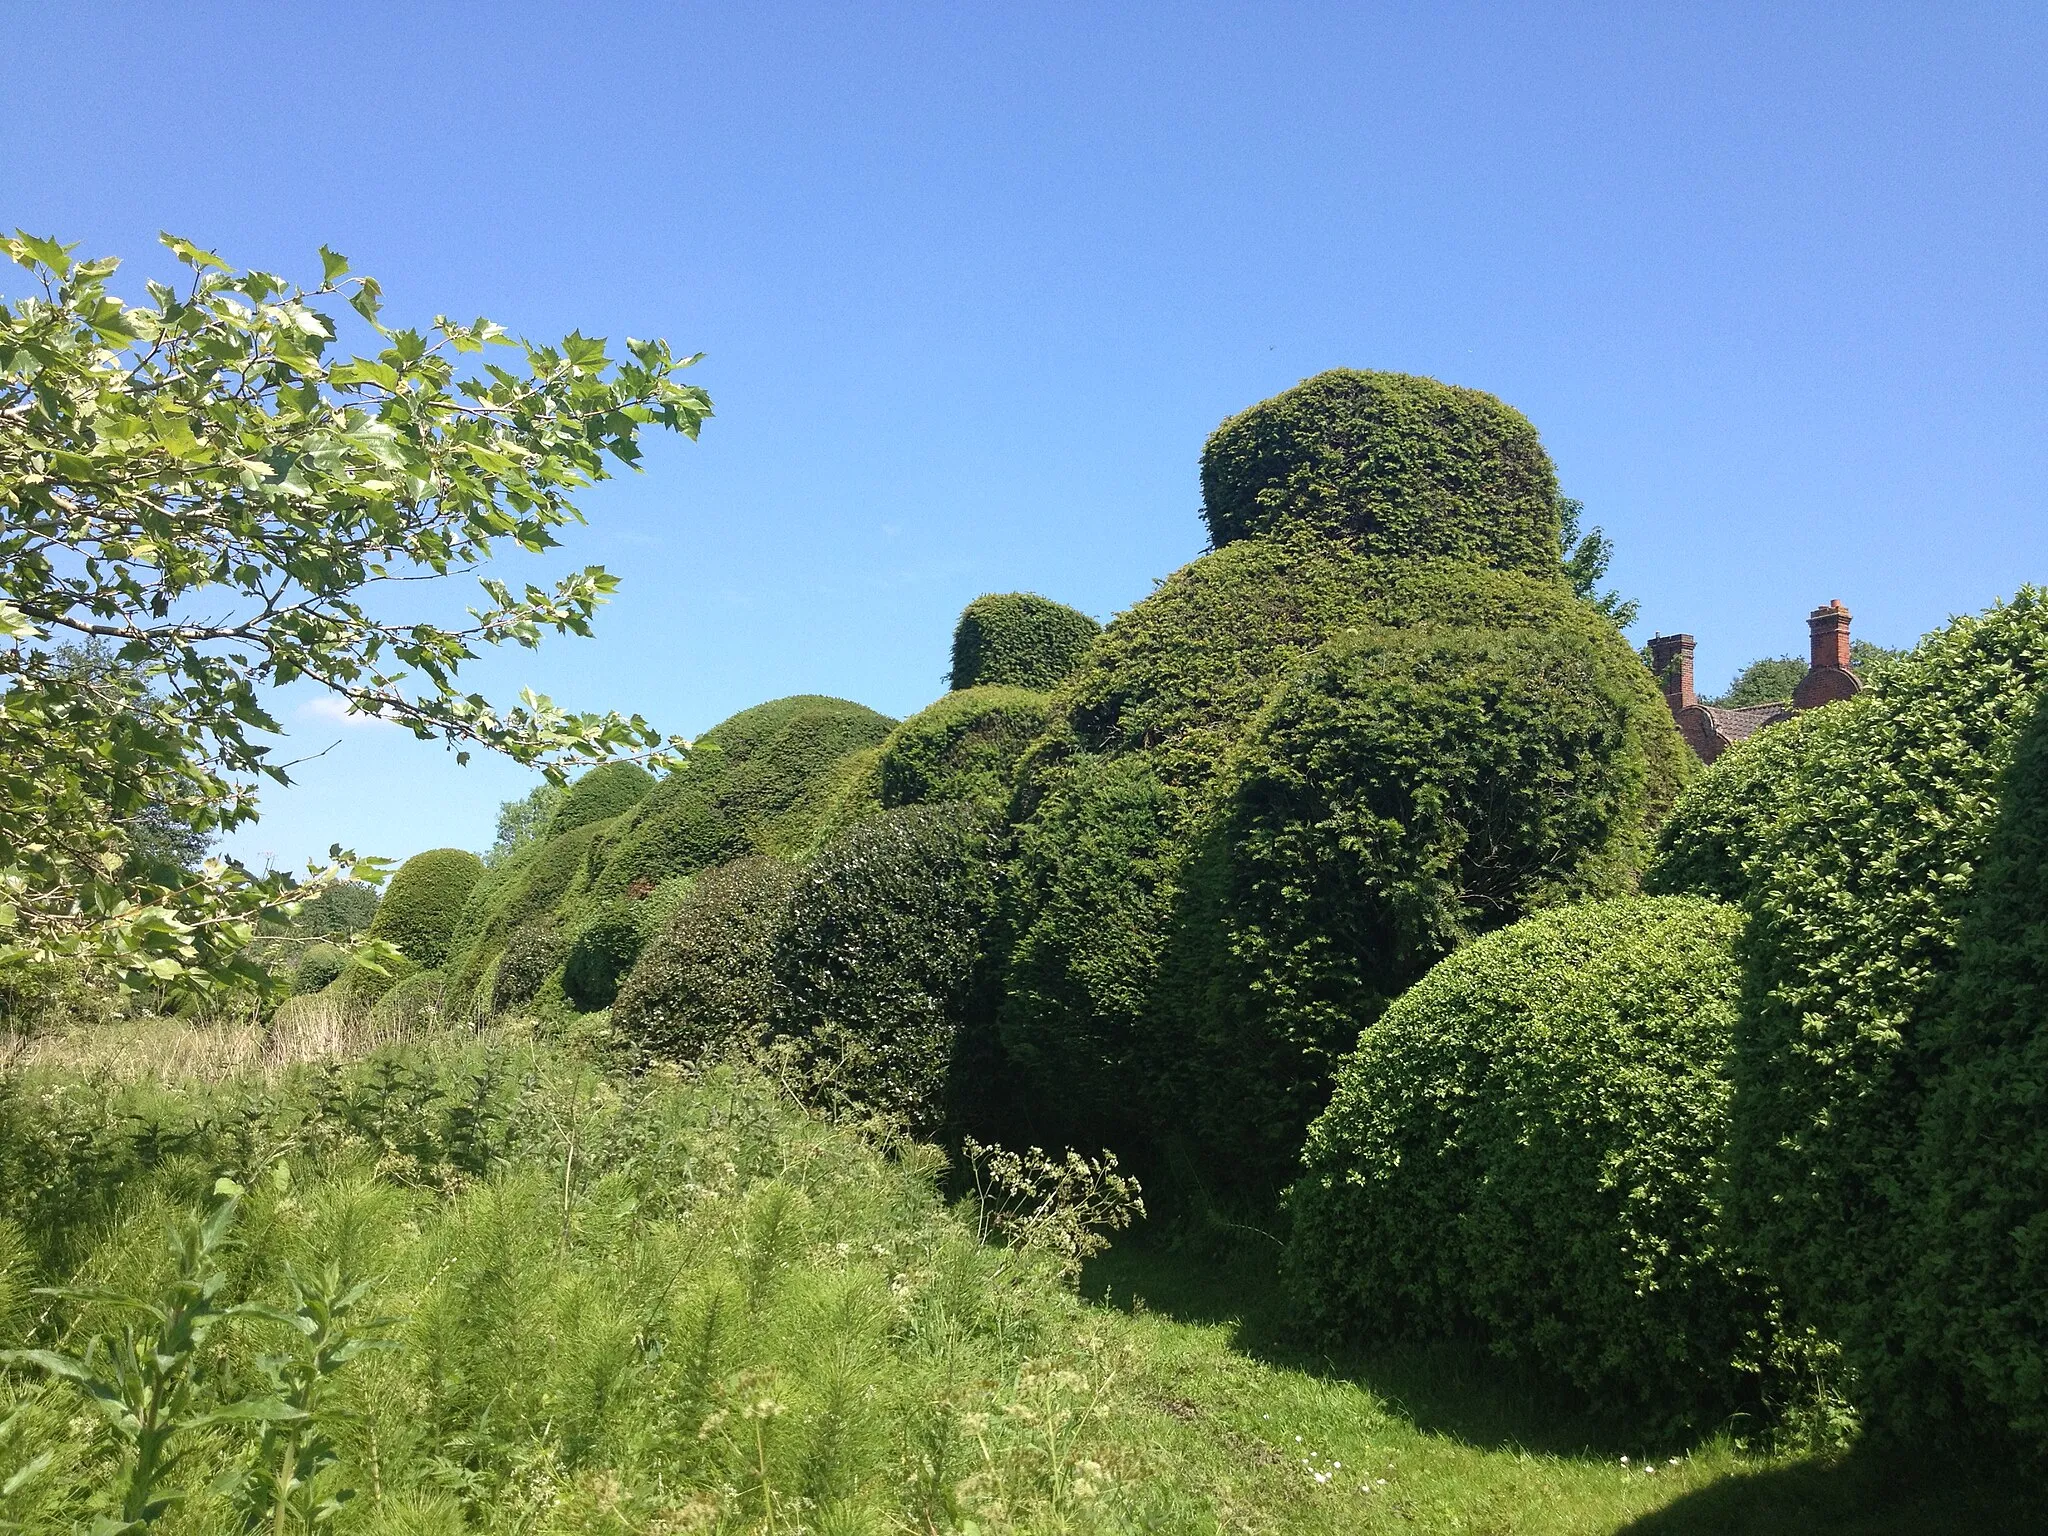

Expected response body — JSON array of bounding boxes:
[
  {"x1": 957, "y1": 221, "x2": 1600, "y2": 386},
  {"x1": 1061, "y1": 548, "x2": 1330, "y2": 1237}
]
[{"x1": 0, "y1": 0, "x2": 2048, "y2": 864}]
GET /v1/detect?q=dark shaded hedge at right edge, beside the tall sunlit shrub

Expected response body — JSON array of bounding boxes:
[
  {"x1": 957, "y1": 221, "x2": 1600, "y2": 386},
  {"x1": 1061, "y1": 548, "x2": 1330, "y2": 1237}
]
[{"x1": 1909, "y1": 702, "x2": 2048, "y2": 1454}]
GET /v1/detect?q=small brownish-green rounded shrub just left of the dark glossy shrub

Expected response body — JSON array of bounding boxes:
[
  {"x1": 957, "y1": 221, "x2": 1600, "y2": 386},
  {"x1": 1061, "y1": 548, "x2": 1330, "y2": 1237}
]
[{"x1": 612, "y1": 858, "x2": 799, "y2": 1063}]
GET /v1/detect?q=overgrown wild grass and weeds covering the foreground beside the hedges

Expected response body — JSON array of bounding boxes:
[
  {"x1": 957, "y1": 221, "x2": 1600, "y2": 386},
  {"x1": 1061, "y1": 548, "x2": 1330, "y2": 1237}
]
[{"x1": 0, "y1": 1028, "x2": 2021, "y2": 1536}]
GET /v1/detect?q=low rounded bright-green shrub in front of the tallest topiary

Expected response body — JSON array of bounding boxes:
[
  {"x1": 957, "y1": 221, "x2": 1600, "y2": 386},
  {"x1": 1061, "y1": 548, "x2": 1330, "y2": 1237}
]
[{"x1": 1288, "y1": 897, "x2": 1769, "y2": 1427}]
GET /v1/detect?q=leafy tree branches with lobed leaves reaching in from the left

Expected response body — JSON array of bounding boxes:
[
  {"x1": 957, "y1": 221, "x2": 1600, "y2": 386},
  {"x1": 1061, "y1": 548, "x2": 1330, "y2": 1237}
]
[{"x1": 0, "y1": 233, "x2": 711, "y2": 991}]
